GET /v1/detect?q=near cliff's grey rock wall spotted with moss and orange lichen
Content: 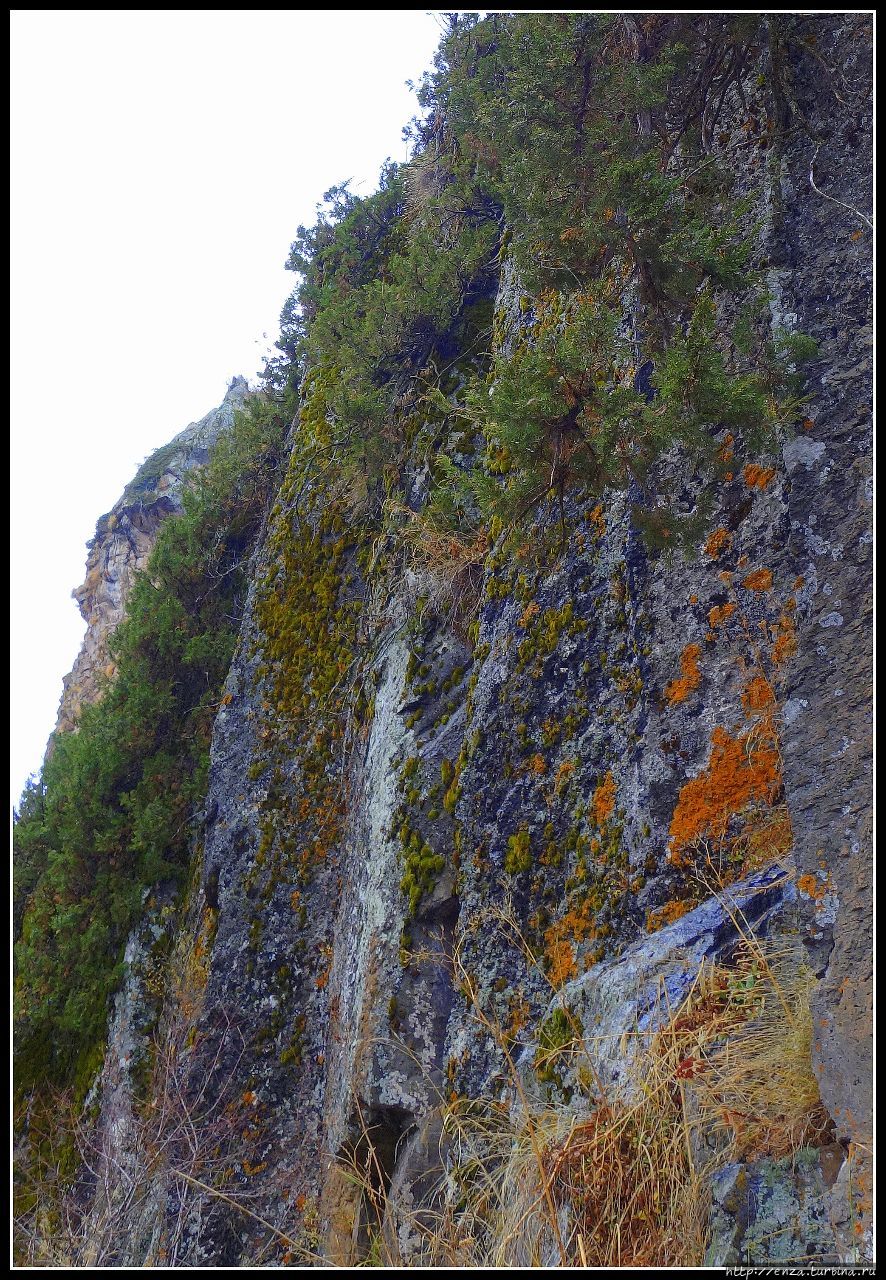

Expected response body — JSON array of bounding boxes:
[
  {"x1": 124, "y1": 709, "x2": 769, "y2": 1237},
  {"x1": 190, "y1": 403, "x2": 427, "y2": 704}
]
[{"x1": 20, "y1": 15, "x2": 872, "y2": 1266}]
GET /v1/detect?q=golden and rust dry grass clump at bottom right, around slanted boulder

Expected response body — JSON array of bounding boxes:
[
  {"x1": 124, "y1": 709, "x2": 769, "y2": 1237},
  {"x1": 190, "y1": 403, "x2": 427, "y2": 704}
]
[{"x1": 343, "y1": 920, "x2": 828, "y2": 1267}]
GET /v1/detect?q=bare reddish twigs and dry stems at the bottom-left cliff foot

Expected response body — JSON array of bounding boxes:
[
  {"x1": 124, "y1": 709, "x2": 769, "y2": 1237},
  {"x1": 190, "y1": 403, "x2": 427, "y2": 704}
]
[{"x1": 13, "y1": 928, "x2": 327, "y2": 1268}]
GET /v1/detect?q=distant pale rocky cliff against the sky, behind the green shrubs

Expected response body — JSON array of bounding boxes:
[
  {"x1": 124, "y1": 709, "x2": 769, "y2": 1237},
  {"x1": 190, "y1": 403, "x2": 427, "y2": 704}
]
[{"x1": 55, "y1": 378, "x2": 248, "y2": 733}]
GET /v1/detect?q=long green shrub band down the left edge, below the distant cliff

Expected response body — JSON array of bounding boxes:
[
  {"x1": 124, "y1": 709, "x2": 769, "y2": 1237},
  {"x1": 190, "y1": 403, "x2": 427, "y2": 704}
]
[{"x1": 14, "y1": 398, "x2": 286, "y2": 1091}]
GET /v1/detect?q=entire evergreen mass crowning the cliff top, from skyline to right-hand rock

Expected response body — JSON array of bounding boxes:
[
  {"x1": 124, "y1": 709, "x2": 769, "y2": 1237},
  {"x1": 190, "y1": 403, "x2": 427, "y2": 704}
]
[{"x1": 271, "y1": 14, "x2": 814, "y2": 552}]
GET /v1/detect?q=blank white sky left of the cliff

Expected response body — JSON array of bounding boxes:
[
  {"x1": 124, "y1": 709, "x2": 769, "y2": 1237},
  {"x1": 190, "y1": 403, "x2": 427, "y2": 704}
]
[{"x1": 10, "y1": 9, "x2": 440, "y2": 803}]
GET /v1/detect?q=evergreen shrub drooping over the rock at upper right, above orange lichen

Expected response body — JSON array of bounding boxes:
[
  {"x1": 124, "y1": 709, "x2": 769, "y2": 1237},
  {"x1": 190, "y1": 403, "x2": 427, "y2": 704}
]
[{"x1": 414, "y1": 14, "x2": 814, "y2": 542}]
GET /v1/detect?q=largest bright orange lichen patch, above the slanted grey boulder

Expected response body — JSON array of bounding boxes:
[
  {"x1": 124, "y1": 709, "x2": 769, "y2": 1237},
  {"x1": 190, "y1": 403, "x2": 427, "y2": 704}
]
[{"x1": 671, "y1": 721, "x2": 781, "y2": 863}]
